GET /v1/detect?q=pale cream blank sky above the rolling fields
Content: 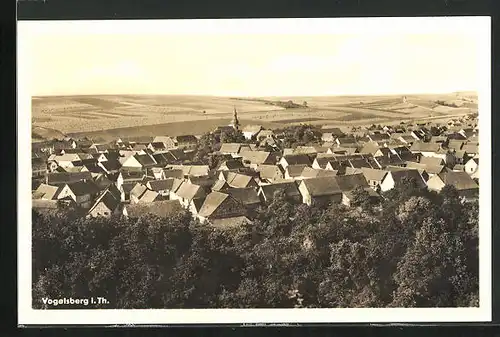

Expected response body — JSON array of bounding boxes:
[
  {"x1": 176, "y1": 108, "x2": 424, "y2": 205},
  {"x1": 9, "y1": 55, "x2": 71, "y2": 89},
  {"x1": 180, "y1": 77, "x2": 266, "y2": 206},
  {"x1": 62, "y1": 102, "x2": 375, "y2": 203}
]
[{"x1": 21, "y1": 20, "x2": 486, "y2": 96}]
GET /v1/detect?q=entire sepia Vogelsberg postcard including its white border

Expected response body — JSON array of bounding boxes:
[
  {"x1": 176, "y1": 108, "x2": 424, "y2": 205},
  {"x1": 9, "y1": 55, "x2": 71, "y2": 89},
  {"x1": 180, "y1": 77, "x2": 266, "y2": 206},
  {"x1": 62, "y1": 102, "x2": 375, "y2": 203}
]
[{"x1": 18, "y1": 17, "x2": 491, "y2": 324}]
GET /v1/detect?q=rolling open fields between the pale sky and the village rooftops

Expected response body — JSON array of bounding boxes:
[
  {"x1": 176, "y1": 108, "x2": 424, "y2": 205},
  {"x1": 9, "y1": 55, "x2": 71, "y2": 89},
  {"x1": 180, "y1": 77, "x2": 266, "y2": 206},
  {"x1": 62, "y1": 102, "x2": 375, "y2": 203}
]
[{"x1": 32, "y1": 93, "x2": 477, "y2": 141}]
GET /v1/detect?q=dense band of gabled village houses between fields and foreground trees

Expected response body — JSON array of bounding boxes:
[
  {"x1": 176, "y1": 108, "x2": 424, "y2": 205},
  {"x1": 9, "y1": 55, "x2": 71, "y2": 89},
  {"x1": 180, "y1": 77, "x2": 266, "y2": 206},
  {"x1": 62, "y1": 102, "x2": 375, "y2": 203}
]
[{"x1": 32, "y1": 115, "x2": 479, "y2": 226}]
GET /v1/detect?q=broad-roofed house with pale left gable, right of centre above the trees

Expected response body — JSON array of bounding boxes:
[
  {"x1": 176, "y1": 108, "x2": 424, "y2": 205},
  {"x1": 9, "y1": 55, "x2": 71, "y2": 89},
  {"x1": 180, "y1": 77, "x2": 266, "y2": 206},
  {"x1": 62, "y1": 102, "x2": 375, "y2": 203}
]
[{"x1": 298, "y1": 177, "x2": 342, "y2": 206}]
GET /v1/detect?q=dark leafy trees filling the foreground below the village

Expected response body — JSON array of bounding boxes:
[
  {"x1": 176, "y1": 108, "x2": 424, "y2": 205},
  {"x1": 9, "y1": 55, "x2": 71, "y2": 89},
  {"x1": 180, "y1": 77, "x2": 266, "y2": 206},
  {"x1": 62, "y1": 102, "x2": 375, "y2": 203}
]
[{"x1": 33, "y1": 177, "x2": 479, "y2": 308}]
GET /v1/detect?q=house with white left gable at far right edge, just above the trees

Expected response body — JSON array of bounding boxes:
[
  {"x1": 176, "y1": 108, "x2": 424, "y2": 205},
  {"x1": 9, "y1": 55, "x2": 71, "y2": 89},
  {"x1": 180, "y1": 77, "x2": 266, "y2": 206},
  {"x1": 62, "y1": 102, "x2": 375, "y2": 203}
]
[{"x1": 427, "y1": 171, "x2": 479, "y2": 199}]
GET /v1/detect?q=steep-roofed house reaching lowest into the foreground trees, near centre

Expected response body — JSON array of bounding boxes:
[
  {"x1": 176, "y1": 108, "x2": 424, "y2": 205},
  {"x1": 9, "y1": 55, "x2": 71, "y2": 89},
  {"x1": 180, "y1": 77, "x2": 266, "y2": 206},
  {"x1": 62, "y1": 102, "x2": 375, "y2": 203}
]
[{"x1": 197, "y1": 191, "x2": 247, "y2": 222}]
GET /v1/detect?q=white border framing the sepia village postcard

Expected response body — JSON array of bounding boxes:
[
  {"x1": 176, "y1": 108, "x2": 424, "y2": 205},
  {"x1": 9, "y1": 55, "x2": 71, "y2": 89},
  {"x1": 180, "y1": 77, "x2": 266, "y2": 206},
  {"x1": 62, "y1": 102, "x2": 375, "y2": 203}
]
[{"x1": 17, "y1": 17, "x2": 492, "y2": 325}]
